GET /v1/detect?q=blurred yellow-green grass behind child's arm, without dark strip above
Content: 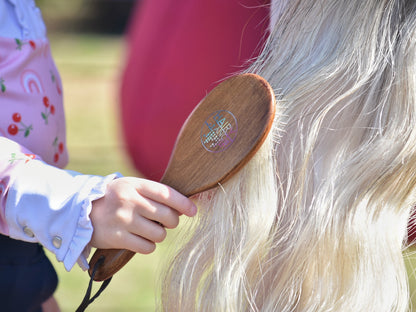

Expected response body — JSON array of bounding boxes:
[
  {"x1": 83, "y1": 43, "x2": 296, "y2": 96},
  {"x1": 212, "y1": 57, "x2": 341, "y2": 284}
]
[{"x1": 45, "y1": 34, "x2": 163, "y2": 312}]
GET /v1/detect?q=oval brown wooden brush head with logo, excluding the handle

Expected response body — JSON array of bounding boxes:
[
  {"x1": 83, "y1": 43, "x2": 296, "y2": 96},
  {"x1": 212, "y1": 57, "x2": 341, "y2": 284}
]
[{"x1": 161, "y1": 74, "x2": 275, "y2": 196}]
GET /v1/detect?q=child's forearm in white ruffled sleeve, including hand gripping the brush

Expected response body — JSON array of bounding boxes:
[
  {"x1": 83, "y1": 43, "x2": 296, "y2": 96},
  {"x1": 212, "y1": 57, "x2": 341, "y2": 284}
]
[{"x1": 0, "y1": 137, "x2": 195, "y2": 270}]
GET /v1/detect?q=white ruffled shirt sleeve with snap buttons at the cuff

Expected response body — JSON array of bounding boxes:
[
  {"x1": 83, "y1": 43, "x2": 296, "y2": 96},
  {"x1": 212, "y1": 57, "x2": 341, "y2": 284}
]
[{"x1": 0, "y1": 137, "x2": 121, "y2": 271}]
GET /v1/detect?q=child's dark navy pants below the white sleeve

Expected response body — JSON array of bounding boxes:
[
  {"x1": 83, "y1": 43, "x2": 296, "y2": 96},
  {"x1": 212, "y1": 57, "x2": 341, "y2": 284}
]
[{"x1": 0, "y1": 234, "x2": 58, "y2": 312}]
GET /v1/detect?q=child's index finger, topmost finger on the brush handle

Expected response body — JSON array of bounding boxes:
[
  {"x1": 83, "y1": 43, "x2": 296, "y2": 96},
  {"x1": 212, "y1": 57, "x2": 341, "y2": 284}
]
[{"x1": 128, "y1": 178, "x2": 197, "y2": 217}]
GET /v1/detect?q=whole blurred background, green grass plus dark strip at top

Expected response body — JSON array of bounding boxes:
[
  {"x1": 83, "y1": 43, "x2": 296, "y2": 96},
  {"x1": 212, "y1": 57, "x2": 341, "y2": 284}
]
[{"x1": 36, "y1": 0, "x2": 164, "y2": 312}]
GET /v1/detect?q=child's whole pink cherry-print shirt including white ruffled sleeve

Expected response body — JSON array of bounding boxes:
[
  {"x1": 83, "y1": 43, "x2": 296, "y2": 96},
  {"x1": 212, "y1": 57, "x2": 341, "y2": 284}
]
[{"x1": 0, "y1": 0, "x2": 120, "y2": 270}]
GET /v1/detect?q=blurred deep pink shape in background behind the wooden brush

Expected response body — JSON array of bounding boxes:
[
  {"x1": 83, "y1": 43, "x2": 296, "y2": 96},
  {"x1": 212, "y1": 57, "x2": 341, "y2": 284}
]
[{"x1": 121, "y1": 0, "x2": 269, "y2": 180}]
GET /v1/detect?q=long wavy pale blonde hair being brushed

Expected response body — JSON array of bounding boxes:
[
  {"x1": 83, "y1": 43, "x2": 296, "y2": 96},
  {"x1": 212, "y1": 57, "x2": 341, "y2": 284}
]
[{"x1": 160, "y1": 0, "x2": 416, "y2": 312}]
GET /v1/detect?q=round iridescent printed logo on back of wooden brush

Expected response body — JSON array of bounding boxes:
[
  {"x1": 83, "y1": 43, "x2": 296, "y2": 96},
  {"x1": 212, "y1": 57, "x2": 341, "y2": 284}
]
[{"x1": 201, "y1": 110, "x2": 238, "y2": 153}]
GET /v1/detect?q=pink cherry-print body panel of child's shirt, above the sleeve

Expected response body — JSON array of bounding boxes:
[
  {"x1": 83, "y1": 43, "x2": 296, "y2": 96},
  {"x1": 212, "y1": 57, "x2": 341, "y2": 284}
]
[{"x1": 0, "y1": 38, "x2": 68, "y2": 168}]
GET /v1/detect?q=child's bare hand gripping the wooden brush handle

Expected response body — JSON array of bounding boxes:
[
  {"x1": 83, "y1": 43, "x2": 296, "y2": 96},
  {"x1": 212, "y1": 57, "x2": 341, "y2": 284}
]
[{"x1": 90, "y1": 177, "x2": 196, "y2": 254}]
